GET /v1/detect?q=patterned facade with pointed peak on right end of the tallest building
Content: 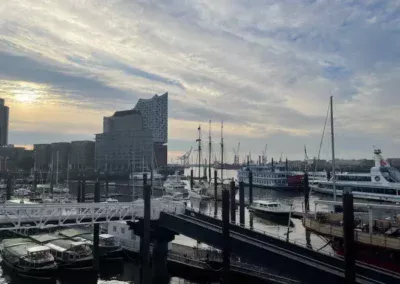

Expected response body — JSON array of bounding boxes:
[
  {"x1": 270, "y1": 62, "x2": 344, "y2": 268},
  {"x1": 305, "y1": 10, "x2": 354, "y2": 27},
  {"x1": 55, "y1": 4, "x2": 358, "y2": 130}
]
[{"x1": 134, "y1": 92, "x2": 168, "y2": 166}]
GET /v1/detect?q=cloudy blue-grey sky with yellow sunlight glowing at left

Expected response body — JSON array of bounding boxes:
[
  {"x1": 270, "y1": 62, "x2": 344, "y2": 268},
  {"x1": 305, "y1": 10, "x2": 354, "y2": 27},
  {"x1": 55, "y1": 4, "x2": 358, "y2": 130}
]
[{"x1": 0, "y1": 0, "x2": 400, "y2": 162}]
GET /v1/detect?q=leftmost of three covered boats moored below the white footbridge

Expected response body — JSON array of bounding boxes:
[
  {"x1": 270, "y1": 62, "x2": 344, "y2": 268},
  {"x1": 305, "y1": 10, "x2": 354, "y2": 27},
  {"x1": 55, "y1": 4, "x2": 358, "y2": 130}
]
[{"x1": 1, "y1": 238, "x2": 57, "y2": 280}]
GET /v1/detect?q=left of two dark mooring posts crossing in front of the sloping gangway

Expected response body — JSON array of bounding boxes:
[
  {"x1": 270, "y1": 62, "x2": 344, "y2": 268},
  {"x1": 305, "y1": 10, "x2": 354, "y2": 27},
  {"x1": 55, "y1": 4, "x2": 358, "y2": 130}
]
[{"x1": 222, "y1": 189, "x2": 231, "y2": 284}]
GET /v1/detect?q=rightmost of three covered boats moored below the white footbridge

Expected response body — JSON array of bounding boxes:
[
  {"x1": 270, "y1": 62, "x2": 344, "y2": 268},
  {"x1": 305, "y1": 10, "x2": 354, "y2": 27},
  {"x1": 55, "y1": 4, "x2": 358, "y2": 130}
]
[{"x1": 58, "y1": 228, "x2": 122, "y2": 260}]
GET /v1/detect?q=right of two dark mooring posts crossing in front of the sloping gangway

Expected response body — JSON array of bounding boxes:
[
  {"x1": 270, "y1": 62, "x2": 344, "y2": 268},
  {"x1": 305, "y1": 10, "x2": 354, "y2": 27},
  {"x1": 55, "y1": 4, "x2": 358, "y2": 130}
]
[{"x1": 342, "y1": 187, "x2": 356, "y2": 284}]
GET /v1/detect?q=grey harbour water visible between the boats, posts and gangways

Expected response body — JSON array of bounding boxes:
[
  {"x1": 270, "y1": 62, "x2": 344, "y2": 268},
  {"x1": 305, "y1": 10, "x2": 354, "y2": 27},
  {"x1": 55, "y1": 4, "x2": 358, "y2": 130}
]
[{"x1": 0, "y1": 165, "x2": 396, "y2": 284}]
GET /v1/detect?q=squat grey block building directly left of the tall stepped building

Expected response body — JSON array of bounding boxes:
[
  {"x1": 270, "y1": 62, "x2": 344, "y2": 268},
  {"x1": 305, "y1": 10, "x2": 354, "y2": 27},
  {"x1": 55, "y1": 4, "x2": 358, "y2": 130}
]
[{"x1": 70, "y1": 141, "x2": 95, "y2": 171}]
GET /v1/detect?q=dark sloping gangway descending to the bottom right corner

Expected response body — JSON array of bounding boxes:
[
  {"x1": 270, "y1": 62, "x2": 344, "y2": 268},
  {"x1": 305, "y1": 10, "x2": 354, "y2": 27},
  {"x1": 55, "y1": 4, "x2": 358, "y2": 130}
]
[{"x1": 158, "y1": 209, "x2": 400, "y2": 284}]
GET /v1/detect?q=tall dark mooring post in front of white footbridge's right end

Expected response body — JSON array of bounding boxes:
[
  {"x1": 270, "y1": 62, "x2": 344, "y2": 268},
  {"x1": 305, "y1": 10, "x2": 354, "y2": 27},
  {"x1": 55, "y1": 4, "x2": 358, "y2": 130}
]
[{"x1": 140, "y1": 174, "x2": 151, "y2": 284}]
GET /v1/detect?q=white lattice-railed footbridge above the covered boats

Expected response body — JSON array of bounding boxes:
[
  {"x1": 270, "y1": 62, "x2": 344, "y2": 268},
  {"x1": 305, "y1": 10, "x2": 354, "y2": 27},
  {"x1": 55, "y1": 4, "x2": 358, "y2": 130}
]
[{"x1": 0, "y1": 199, "x2": 185, "y2": 230}]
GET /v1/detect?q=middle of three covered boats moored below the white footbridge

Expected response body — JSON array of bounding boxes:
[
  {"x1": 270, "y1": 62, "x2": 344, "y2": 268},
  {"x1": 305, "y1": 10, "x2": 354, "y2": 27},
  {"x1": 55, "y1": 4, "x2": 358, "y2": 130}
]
[{"x1": 30, "y1": 234, "x2": 93, "y2": 271}]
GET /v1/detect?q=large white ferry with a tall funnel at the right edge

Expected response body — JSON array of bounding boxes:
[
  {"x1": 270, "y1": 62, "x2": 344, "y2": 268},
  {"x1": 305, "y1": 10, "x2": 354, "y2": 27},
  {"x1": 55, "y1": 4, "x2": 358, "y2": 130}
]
[{"x1": 310, "y1": 149, "x2": 400, "y2": 202}]
